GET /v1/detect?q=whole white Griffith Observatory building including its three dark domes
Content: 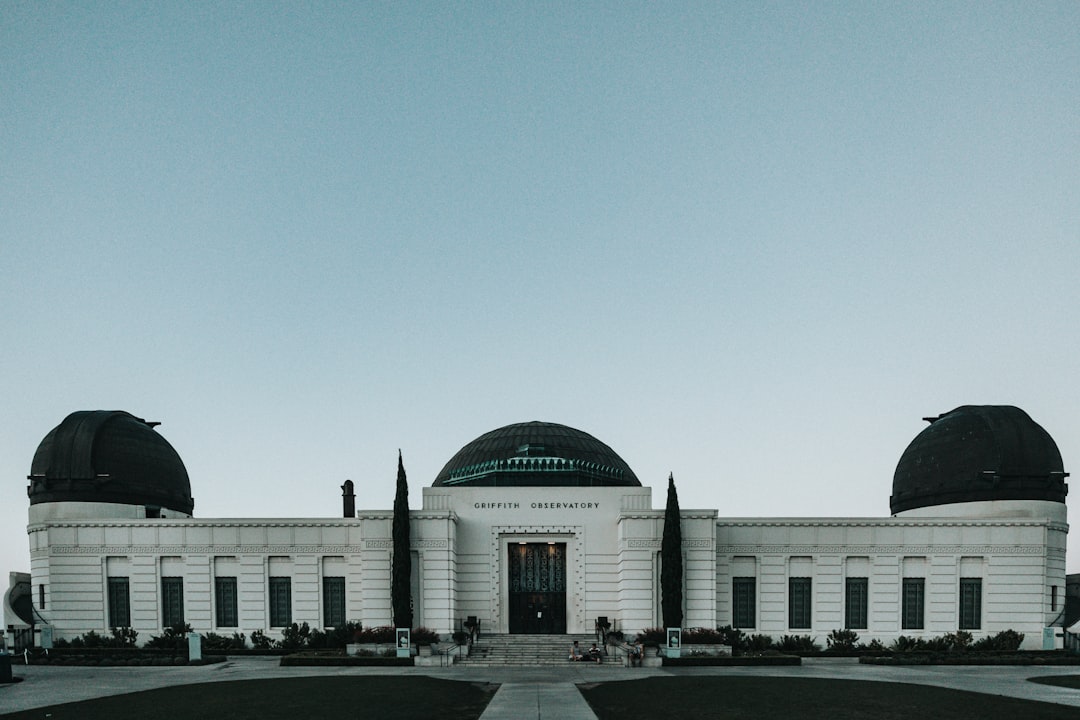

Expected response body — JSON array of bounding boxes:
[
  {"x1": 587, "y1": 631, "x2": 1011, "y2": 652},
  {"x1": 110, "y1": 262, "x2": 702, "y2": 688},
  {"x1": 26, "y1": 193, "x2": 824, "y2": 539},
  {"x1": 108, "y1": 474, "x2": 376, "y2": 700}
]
[{"x1": 4, "y1": 406, "x2": 1068, "y2": 648}]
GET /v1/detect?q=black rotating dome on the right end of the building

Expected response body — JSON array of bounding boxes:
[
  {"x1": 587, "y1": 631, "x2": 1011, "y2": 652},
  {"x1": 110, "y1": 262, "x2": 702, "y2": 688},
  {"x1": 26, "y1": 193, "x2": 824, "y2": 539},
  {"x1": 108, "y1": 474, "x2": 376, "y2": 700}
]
[{"x1": 889, "y1": 405, "x2": 1068, "y2": 514}]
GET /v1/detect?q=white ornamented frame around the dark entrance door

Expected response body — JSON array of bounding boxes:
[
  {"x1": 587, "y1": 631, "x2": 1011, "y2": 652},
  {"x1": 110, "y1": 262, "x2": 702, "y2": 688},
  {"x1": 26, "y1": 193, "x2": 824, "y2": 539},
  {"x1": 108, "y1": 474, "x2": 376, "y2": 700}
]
[{"x1": 489, "y1": 525, "x2": 589, "y2": 634}]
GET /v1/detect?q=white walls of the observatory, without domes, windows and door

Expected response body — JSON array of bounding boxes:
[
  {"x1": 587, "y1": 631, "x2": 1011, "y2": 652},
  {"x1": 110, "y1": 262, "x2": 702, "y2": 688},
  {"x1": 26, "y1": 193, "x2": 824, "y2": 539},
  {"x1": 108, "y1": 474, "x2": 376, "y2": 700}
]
[{"x1": 21, "y1": 487, "x2": 1068, "y2": 648}]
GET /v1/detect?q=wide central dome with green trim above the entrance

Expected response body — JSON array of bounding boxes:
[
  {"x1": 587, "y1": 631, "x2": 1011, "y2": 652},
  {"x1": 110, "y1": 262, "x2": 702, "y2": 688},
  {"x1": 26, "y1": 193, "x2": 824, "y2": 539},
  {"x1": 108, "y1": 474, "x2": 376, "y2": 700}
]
[{"x1": 433, "y1": 422, "x2": 642, "y2": 487}]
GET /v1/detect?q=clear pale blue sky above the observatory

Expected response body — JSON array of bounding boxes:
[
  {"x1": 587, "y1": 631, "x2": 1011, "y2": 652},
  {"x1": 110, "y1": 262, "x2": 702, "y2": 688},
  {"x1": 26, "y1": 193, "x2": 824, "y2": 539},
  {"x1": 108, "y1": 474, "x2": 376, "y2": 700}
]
[{"x1": 0, "y1": 0, "x2": 1080, "y2": 571}]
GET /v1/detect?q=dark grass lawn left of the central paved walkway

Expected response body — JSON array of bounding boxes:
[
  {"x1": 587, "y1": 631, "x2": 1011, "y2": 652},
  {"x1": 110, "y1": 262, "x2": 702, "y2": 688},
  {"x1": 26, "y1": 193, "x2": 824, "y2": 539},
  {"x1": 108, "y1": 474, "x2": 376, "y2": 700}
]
[{"x1": 2, "y1": 676, "x2": 498, "y2": 720}]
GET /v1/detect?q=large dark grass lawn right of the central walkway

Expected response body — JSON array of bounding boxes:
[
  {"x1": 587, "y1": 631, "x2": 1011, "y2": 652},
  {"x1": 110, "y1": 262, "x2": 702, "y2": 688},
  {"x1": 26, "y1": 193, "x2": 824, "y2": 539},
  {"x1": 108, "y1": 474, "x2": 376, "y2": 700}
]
[{"x1": 581, "y1": 676, "x2": 1080, "y2": 720}]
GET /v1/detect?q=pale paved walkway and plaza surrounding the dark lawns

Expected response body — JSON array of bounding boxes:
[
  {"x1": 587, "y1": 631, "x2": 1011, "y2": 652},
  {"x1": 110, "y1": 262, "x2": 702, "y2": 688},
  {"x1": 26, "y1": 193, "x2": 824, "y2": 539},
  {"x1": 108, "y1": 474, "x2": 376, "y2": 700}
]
[{"x1": 0, "y1": 657, "x2": 1080, "y2": 720}]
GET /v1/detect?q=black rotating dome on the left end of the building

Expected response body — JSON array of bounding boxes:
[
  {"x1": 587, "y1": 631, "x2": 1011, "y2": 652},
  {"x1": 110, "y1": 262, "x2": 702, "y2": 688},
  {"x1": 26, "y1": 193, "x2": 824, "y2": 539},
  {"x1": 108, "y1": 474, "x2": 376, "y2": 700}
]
[{"x1": 28, "y1": 410, "x2": 194, "y2": 515}]
